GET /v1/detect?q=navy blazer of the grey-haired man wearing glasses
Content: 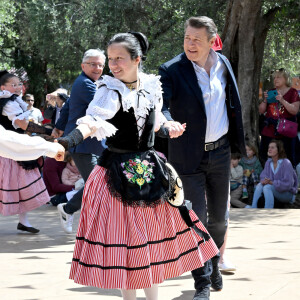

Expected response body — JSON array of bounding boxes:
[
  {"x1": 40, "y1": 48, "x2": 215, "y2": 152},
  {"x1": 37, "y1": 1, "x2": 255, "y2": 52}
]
[{"x1": 64, "y1": 72, "x2": 103, "y2": 156}]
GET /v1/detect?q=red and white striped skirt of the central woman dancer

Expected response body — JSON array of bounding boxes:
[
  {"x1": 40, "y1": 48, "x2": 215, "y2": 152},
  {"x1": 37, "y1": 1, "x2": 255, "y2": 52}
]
[{"x1": 70, "y1": 166, "x2": 219, "y2": 289}]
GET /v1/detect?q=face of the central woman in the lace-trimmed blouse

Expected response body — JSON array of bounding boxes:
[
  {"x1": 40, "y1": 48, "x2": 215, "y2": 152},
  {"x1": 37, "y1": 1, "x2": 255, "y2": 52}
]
[{"x1": 107, "y1": 43, "x2": 141, "y2": 82}]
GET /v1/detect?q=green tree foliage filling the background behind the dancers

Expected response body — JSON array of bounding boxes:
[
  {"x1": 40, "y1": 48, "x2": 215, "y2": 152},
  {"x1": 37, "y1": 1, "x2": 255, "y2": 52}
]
[{"x1": 0, "y1": 0, "x2": 300, "y2": 108}]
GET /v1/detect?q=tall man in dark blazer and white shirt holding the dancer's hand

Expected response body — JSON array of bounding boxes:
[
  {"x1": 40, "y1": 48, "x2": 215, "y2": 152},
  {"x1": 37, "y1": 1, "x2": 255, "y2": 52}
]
[{"x1": 159, "y1": 17, "x2": 245, "y2": 300}]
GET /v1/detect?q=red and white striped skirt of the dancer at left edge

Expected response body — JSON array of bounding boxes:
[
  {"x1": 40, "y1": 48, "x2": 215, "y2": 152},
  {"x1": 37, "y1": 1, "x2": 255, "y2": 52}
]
[{"x1": 0, "y1": 156, "x2": 50, "y2": 216}]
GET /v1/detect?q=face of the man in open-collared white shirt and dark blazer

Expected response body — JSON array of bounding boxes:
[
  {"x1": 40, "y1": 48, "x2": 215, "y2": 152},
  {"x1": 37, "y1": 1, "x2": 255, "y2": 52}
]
[{"x1": 183, "y1": 26, "x2": 216, "y2": 67}]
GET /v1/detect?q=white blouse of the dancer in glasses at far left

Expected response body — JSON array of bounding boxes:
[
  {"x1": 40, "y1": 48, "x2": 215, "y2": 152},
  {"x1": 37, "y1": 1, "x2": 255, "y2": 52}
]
[{"x1": 0, "y1": 91, "x2": 30, "y2": 129}]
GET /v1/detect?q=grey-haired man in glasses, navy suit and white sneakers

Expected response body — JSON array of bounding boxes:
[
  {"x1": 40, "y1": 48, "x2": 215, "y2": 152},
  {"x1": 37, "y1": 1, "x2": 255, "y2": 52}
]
[{"x1": 52, "y1": 49, "x2": 105, "y2": 233}]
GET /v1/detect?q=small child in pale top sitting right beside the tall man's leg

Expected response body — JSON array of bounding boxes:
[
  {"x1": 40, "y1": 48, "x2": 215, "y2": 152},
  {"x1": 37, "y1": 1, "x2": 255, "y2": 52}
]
[{"x1": 230, "y1": 153, "x2": 246, "y2": 208}]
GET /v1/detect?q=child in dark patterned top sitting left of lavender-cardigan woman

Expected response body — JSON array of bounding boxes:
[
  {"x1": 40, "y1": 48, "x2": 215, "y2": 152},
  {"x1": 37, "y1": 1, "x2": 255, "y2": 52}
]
[{"x1": 239, "y1": 144, "x2": 262, "y2": 199}]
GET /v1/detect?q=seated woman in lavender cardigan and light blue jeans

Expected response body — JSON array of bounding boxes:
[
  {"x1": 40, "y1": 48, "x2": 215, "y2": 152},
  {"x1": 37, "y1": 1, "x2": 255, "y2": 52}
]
[{"x1": 248, "y1": 140, "x2": 298, "y2": 208}]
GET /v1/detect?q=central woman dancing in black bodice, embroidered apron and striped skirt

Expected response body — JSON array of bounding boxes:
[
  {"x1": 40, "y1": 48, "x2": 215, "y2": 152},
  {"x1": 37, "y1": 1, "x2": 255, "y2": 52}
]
[{"x1": 59, "y1": 32, "x2": 218, "y2": 300}]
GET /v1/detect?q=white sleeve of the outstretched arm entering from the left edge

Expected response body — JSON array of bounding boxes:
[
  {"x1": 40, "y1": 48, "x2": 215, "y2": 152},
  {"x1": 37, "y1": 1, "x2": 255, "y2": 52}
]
[{"x1": 0, "y1": 125, "x2": 61, "y2": 160}]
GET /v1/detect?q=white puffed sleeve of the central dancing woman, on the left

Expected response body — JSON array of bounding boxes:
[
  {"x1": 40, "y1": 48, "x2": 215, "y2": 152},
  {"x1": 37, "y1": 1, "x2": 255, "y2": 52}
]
[{"x1": 77, "y1": 86, "x2": 121, "y2": 141}]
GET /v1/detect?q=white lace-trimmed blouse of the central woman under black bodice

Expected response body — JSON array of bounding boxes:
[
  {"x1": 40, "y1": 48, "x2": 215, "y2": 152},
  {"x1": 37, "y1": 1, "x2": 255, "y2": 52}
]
[{"x1": 77, "y1": 73, "x2": 166, "y2": 140}]
